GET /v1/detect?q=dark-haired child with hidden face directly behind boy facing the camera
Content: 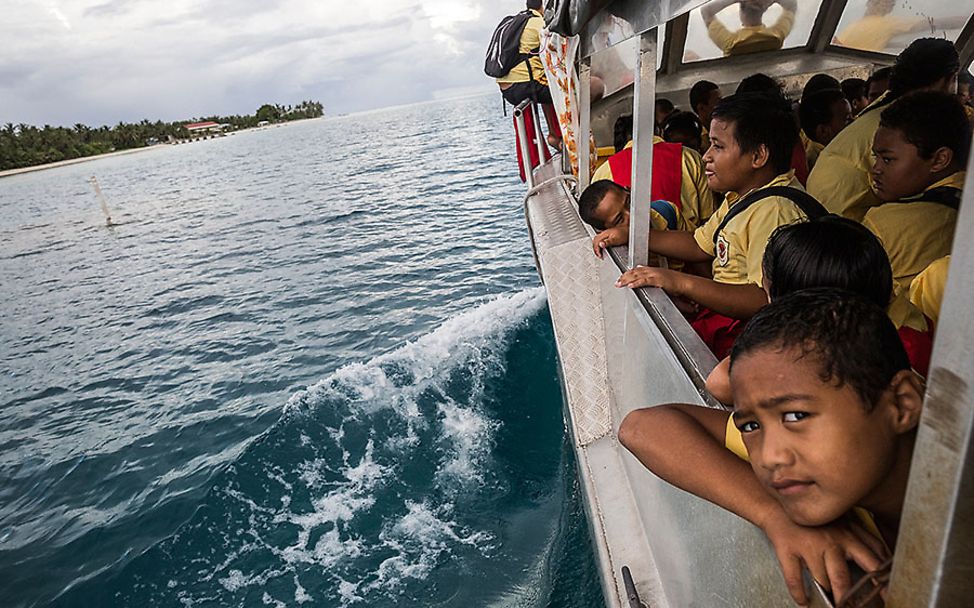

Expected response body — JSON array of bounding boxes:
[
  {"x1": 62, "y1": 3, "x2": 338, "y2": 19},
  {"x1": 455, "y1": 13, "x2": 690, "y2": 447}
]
[{"x1": 707, "y1": 215, "x2": 933, "y2": 403}]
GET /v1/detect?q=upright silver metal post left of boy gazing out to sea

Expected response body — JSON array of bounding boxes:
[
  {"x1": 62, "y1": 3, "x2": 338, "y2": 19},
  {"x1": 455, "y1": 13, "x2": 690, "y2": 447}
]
[{"x1": 629, "y1": 28, "x2": 656, "y2": 268}]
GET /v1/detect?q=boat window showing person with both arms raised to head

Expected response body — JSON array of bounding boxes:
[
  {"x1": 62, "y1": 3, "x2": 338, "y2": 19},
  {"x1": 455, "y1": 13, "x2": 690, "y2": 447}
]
[{"x1": 683, "y1": 0, "x2": 822, "y2": 63}]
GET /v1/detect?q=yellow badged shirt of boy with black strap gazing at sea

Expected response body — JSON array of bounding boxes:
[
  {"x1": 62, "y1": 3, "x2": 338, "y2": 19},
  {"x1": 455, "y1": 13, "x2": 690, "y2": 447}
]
[{"x1": 693, "y1": 171, "x2": 807, "y2": 285}]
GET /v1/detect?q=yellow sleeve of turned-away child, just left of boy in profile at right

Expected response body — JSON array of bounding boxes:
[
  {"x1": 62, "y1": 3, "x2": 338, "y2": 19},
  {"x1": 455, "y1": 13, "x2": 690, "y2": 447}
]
[{"x1": 806, "y1": 146, "x2": 880, "y2": 222}]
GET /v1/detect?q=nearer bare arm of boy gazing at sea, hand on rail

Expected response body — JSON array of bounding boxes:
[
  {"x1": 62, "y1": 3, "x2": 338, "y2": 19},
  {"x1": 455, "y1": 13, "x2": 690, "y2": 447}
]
[{"x1": 616, "y1": 268, "x2": 768, "y2": 319}]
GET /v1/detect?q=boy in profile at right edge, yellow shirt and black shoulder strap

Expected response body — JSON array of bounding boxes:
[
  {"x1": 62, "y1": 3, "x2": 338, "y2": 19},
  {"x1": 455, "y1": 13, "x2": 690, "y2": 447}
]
[{"x1": 863, "y1": 91, "x2": 971, "y2": 291}]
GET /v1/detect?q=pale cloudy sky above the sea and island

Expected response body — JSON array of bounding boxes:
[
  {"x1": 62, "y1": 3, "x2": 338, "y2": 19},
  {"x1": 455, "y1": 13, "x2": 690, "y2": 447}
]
[{"x1": 0, "y1": 0, "x2": 523, "y2": 125}]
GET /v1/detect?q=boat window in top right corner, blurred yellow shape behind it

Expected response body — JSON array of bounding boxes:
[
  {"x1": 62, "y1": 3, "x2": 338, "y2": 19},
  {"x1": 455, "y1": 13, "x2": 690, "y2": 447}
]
[{"x1": 833, "y1": 0, "x2": 974, "y2": 55}]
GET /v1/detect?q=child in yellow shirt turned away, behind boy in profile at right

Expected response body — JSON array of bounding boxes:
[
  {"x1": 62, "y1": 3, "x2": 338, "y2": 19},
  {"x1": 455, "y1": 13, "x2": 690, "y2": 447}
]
[{"x1": 808, "y1": 38, "x2": 960, "y2": 221}]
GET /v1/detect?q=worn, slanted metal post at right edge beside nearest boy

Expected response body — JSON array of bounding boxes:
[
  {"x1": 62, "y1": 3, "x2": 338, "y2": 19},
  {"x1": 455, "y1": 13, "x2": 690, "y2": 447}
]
[{"x1": 886, "y1": 140, "x2": 974, "y2": 608}]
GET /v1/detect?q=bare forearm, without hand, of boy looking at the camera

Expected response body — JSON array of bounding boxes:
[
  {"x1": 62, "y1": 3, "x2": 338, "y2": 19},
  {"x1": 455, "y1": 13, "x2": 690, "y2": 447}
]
[{"x1": 619, "y1": 405, "x2": 781, "y2": 528}]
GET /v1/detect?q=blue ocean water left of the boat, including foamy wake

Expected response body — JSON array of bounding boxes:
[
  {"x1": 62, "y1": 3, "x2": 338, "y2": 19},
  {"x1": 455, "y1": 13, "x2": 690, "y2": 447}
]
[{"x1": 0, "y1": 96, "x2": 601, "y2": 608}]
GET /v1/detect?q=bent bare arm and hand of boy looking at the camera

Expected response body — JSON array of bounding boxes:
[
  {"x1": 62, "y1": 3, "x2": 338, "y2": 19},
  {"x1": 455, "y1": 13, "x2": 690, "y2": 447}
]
[{"x1": 619, "y1": 405, "x2": 884, "y2": 605}]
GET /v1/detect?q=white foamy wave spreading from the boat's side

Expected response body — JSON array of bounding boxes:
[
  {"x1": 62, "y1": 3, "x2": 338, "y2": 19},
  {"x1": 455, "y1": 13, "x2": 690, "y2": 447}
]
[{"x1": 63, "y1": 288, "x2": 545, "y2": 606}]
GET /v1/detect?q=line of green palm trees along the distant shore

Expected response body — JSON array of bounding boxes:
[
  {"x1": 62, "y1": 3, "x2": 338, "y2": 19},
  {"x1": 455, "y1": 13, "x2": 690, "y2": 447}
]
[{"x1": 0, "y1": 101, "x2": 324, "y2": 171}]
